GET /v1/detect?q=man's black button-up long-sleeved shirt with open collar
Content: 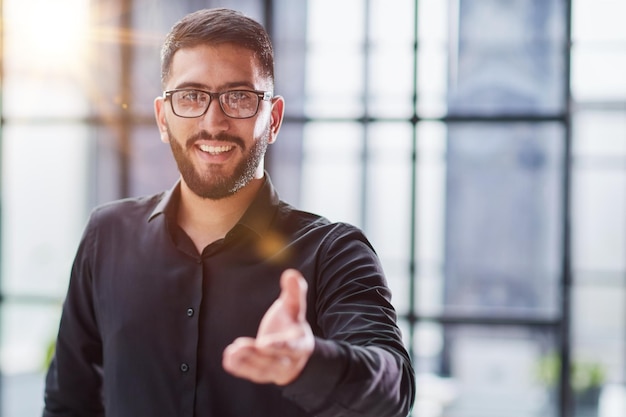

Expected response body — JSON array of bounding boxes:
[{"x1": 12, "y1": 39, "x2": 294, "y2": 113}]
[{"x1": 43, "y1": 176, "x2": 414, "y2": 417}]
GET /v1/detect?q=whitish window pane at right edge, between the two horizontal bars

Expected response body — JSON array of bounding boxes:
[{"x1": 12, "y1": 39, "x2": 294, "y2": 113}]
[{"x1": 572, "y1": 111, "x2": 626, "y2": 274}]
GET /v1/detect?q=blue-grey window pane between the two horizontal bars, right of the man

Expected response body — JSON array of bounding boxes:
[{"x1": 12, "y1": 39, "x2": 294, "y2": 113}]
[{"x1": 444, "y1": 123, "x2": 563, "y2": 316}]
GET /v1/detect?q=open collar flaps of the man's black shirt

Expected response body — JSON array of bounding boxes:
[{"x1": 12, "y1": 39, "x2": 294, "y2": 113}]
[{"x1": 148, "y1": 171, "x2": 280, "y2": 236}]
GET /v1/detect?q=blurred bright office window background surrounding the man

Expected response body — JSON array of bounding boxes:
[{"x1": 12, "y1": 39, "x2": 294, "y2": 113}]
[{"x1": 0, "y1": 0, "x2": 626, "y2": 417}]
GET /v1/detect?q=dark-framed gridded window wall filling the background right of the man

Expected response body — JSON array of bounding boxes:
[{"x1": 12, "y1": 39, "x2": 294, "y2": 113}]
[{"x1": 271, "y1": 0, "x2": 626, "y2": 416}]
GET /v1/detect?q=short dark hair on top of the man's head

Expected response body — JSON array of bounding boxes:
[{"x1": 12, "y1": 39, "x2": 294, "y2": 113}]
[{"x1": 161, "y1": 8, "x2": 274, "y2": 86}]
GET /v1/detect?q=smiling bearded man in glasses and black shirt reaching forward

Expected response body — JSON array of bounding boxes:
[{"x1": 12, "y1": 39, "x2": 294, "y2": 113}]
[{"x1": 43, "y1": 9, "x2": 414, "y2": 417}]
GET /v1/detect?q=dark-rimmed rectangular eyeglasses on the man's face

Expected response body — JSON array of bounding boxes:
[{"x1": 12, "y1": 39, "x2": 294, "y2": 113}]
[{"x1": 163, "y1": 88, "x2": 273, "y2": 119}]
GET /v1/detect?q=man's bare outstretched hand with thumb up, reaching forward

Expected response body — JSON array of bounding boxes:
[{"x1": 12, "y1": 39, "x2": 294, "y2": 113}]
[{"x1": 222, "y1": 269, "x2": 315, "y2": 385}]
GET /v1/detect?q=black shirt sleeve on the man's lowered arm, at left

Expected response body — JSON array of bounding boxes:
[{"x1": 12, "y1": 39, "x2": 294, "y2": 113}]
[{"x1": 43, "y1": 214, "x2": 104, "y2": 417}]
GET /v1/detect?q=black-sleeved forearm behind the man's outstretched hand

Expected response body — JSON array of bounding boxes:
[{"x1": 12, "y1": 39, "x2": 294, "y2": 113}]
[{"x1": 283, "y1": 338, "x2": 415, "y2": 417}]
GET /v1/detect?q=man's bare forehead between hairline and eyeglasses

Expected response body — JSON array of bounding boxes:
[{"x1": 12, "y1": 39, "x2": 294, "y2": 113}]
[{"x1": 167, "y1": 44, "x2": 265, "y2": 89}]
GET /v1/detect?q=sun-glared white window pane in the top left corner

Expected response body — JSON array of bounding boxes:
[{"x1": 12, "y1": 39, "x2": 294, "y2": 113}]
[{"x1": 2, "y1": 0, "x2": 89, "y2": 119}]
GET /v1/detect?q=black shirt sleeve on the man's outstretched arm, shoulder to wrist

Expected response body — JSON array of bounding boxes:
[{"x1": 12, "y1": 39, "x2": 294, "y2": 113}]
[{"x1": 283, "y1": 225, "x2": 415, "y2": 417}]
